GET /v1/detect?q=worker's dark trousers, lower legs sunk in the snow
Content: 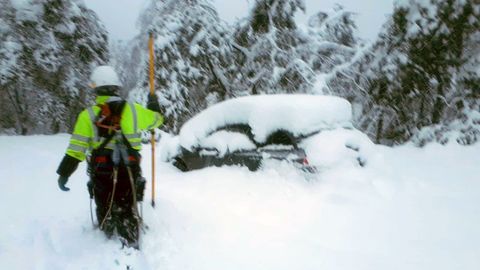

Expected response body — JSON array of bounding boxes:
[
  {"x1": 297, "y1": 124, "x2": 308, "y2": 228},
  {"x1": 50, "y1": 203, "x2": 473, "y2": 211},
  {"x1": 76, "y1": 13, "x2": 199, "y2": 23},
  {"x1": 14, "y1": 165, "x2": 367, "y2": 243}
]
[{"x1": 90, "y1": 150, "x2": 145, "y2": 245}]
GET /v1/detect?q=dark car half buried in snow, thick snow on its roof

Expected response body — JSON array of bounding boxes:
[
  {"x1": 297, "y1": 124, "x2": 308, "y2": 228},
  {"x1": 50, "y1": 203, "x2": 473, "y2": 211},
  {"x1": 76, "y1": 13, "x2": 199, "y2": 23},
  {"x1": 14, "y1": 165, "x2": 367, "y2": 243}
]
[{"x1": 172, "y1": 95, "x2": 368, "y2": 172}]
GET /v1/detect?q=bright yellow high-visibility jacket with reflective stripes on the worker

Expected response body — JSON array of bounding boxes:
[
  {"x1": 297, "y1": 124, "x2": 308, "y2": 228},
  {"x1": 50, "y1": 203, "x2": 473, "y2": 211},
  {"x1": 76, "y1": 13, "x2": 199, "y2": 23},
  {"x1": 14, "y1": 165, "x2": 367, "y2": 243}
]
[{"x1": 66, "y1": 96, "x2": 163, "y2": 161}]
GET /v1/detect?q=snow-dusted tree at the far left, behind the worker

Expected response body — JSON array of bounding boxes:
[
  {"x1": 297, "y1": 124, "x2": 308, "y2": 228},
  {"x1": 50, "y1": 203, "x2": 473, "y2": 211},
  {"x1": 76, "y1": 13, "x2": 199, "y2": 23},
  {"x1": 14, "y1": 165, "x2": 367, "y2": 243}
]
[{"x1": 0, "y1": 0, "x2": 107, "y2": 134}]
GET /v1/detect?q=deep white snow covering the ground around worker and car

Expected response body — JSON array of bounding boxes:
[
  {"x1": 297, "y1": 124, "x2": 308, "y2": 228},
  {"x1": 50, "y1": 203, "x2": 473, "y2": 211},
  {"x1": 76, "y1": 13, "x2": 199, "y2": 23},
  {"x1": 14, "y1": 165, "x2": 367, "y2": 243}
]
[{"x1": 0, "y1": 135, "x2": 480, "y2": 270}]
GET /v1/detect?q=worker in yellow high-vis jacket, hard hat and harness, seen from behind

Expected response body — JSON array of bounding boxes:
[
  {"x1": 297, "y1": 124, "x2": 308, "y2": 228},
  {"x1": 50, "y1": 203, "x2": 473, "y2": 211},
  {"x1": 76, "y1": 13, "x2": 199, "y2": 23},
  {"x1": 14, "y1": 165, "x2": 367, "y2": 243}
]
[{"x1": 57, "y1": 66, "x2": 163, "y2": 247}]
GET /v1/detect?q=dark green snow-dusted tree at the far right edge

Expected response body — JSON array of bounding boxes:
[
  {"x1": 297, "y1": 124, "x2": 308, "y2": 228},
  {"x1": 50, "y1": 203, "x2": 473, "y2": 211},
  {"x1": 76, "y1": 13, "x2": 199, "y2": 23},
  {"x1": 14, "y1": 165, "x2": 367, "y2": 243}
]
[{"x1": 329, "y1": 0, "x2": 480, "y2": 146}]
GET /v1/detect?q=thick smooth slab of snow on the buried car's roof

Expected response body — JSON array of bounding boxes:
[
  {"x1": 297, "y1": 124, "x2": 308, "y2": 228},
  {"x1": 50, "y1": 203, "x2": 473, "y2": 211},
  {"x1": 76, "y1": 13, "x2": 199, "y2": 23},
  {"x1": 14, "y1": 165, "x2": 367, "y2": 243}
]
[{"x1": 180, "y1": 94, "x2": 352, "y2": 149}]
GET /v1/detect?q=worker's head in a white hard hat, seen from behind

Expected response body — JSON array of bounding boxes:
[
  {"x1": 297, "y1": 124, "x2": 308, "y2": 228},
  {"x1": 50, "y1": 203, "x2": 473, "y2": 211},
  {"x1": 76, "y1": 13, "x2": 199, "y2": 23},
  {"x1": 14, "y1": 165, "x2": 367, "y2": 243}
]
[{"x1": 90, "y1": 66, "x2": 122, "y2": 96}]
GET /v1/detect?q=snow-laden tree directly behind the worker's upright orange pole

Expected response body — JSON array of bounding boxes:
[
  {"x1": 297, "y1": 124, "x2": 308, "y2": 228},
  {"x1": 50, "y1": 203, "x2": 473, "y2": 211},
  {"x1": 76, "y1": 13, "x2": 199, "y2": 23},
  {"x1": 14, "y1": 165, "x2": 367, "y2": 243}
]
[{"x1": 126, "y1": 0, "x2": 231, "y2": 130}]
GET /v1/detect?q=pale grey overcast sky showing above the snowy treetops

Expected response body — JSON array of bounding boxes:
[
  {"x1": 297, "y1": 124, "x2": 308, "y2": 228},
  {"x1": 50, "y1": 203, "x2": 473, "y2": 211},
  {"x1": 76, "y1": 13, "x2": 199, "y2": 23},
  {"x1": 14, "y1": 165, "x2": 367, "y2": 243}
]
[{"x1": 84, "y1": 0, "x2": 395, "y2": 40}]
